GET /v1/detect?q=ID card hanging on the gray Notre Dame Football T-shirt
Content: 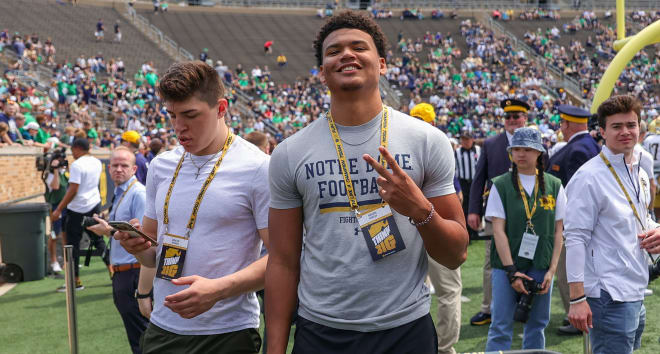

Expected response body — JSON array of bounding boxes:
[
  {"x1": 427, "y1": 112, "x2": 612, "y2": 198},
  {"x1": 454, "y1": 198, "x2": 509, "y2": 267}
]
[{"x1": 356, "y1": 204, "x2": 406, "y2": 262}]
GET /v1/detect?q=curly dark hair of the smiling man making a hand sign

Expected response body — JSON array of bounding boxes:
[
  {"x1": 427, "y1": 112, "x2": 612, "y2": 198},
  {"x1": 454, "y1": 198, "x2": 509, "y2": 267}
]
[{"x1": 314, "y1": 10, "x2": 387, "y2": 66}]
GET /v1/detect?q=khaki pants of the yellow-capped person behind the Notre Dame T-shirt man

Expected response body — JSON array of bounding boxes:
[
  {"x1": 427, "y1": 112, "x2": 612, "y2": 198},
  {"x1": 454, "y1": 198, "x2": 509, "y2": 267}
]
[{"x1": 428, "y1": 257, "x2": 463, "y2": 354}]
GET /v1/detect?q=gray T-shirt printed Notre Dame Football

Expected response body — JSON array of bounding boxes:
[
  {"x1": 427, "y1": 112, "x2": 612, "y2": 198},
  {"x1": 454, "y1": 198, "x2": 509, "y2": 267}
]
[{"x1": 269, "y1": 108, "x2": 455, "y2": 332}]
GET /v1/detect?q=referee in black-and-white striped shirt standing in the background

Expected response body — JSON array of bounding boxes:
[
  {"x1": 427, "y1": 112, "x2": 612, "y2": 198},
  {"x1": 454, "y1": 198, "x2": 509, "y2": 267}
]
[{"x1": 454, "y1": 127, "x2": 481, "y2": 239}]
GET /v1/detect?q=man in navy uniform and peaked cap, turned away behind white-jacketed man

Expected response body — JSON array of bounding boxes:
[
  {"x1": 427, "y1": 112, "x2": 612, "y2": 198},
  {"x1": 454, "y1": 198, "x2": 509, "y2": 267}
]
[{"x1": 547, "y1": 105, "x2": 600, "y2": 335}]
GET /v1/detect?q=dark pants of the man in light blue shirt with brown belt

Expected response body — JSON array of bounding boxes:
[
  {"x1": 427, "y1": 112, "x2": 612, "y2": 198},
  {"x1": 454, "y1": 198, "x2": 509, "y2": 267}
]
[{"x1": 112, "y1": 268, "x2": 149, "y2": 354}]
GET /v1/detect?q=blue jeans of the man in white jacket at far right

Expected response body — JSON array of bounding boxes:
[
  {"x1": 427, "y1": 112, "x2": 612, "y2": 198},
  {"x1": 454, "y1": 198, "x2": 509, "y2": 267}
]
[{"x1": 587, "y1": 289, "x2": 646, "y2": 354}]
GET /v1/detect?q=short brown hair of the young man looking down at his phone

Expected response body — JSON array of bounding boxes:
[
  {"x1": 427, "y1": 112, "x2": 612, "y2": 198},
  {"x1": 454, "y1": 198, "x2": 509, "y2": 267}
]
[{"x1": 156, "y1": 60, "x2": 225, "y2": 107}]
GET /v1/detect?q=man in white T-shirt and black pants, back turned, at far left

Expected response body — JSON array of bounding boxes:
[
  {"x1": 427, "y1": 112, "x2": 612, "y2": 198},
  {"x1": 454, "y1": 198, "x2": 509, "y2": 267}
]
[{"x1": 50, "y1": 138, "x2": 105, "y2": 292}]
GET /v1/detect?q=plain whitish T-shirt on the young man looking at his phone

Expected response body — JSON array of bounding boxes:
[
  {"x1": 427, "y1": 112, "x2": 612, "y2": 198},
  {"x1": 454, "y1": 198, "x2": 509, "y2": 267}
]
[{"x1": 144, "y1": 137, "x2": 269, "y2": 335}]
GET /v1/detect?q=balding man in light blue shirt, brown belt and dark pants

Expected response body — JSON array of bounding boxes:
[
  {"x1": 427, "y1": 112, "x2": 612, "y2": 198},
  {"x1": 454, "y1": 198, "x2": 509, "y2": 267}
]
[{"x1": 87, "y1": 146, "x2": 150, "y2": 354}]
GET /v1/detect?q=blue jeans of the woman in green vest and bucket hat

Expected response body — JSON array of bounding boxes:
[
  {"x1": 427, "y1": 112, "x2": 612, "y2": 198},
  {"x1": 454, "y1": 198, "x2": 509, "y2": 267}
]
[{"x1": 486, "y1": 268, "x2": 552, "y2": 352}]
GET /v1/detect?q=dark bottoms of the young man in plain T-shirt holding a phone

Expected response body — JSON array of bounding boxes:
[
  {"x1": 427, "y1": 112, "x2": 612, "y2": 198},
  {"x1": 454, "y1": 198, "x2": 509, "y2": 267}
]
[{"x1": 142, "y1": 323, "x2": 261, "y2": 354}]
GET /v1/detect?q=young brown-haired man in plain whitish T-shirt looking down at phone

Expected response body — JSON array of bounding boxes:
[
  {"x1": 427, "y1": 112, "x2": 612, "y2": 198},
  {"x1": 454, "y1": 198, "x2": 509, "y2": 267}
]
[{"x1": 114, "y1": 61, "x2": 269, "y2": 353}]
